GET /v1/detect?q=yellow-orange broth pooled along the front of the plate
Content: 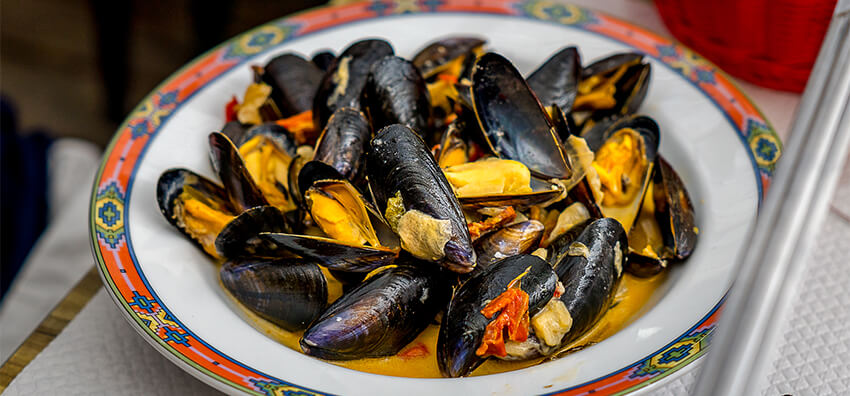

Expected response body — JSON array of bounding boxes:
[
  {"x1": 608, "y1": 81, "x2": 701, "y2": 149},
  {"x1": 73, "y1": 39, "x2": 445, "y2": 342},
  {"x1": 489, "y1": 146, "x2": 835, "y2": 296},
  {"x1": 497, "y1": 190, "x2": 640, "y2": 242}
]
[{"x1": 228, "y1": 271, "x2": 667, "y2": 378}]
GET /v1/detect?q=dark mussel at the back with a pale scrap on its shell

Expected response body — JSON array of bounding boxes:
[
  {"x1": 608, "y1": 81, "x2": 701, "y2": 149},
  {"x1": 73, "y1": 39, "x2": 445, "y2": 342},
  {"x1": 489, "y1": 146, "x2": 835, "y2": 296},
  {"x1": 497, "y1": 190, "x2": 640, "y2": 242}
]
[{"x1": 313, "y1": 39, "x2": 394, "y2": 129}]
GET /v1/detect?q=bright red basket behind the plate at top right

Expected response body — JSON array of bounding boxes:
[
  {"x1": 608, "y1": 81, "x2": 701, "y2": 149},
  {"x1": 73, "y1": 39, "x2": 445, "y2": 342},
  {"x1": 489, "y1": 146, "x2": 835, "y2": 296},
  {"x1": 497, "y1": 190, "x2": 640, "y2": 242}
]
[{"x1": 655, "y1": 0, "x2": 837, "y2": 92}]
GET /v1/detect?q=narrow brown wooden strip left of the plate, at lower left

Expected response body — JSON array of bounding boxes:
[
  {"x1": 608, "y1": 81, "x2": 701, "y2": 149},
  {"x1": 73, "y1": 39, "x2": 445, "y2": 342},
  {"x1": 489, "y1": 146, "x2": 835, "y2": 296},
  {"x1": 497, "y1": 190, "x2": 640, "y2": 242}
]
[{"x1": 0, "y1": 267, "x2": 102, "y2": 393}]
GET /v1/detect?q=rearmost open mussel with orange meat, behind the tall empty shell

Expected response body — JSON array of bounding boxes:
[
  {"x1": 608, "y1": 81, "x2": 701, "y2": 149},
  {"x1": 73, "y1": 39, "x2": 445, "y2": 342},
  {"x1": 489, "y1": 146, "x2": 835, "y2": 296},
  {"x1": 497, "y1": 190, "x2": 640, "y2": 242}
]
[{"x1": 413, "y1": 36, "x2": 486, "y2": 79}]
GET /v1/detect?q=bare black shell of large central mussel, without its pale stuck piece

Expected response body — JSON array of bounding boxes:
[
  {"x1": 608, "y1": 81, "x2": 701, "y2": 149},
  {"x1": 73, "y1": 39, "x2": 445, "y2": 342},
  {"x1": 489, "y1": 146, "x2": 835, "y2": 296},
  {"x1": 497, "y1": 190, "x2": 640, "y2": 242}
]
[{"x1": 366, "y1": 124, "x2": 475, "y2": 273}]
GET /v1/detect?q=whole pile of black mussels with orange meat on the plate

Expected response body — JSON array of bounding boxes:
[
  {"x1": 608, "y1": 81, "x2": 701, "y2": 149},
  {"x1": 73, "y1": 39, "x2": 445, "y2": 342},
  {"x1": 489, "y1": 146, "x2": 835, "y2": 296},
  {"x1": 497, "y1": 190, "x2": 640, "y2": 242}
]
[{"x1": 157, "y1": 37, "x2": 698, "y2": 377}]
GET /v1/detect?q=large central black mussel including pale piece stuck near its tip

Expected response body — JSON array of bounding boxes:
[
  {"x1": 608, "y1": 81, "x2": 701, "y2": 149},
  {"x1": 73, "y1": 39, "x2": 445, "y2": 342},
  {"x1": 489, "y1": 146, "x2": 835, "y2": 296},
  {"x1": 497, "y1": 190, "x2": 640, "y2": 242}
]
[{"x1": 366, "y1": 124, "x2": 475, "y2": 273}]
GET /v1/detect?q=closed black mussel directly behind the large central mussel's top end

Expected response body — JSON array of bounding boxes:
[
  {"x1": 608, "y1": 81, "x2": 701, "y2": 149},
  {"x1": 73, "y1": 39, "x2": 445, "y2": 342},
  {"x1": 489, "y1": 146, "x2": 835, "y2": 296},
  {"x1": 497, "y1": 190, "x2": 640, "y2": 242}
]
[{"x1": 362, "y1": 56, "x2": 434, "y2": 136}]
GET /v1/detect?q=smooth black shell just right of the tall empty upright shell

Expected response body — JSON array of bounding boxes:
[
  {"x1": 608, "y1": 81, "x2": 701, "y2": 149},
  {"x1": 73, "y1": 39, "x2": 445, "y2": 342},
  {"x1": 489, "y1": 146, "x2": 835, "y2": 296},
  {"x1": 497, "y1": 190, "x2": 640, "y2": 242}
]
[{"x1": 528, "y1": 47, "x2": 581, "y2": 111}]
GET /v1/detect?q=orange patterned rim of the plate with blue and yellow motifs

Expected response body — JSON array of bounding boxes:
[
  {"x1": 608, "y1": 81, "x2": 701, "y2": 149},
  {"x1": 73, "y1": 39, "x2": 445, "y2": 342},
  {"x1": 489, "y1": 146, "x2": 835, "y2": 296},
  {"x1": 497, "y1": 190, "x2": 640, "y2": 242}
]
[{"x1": 89, "y1": 0, "x2": 782, "y2": 395}]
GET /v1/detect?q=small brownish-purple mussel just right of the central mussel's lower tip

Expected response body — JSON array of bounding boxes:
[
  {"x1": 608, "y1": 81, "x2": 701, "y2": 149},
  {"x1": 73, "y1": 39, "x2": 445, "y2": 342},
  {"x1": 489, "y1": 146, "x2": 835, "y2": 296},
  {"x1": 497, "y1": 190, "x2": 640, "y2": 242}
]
[{"x1": 475, "y1": 220, "x2": 543, "y2": 269}]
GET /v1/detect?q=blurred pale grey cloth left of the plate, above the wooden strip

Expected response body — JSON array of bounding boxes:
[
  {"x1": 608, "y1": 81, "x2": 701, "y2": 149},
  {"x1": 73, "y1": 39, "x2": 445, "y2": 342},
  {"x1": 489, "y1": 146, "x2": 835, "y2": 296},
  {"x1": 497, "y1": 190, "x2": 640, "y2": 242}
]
[{"x1": 0, "y1": 139, "x2": 100, "y2": 361}]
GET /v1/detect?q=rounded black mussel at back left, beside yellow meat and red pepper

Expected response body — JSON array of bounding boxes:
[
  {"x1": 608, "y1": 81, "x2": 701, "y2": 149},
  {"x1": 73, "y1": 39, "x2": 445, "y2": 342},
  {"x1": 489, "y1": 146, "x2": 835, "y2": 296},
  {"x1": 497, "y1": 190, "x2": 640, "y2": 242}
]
[{"x1": 263, "y1": 53, "x2": 323, "y2": 118}]
